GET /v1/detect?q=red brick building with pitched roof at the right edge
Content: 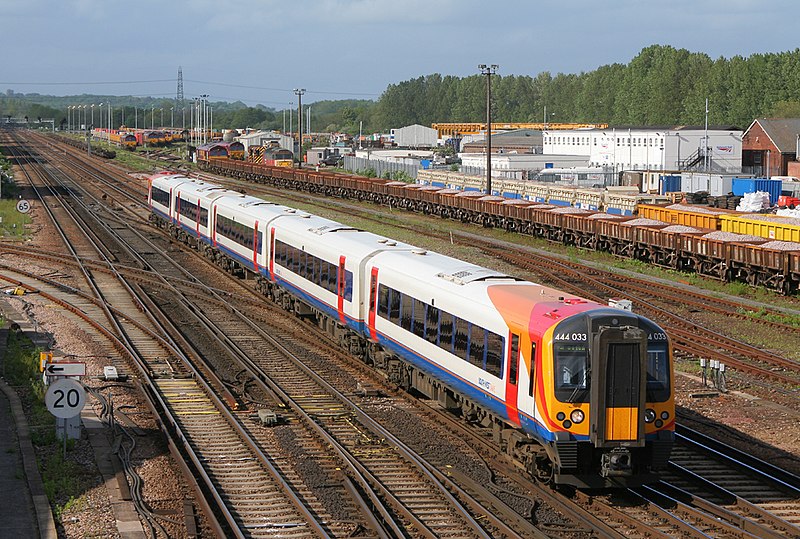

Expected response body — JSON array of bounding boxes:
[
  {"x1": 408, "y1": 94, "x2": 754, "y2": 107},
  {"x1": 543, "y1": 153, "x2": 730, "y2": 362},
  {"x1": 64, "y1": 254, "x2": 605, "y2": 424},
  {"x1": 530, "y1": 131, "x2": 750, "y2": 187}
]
[{"x1": 742, "y1": 118, "x2": 800, "y2": 178}]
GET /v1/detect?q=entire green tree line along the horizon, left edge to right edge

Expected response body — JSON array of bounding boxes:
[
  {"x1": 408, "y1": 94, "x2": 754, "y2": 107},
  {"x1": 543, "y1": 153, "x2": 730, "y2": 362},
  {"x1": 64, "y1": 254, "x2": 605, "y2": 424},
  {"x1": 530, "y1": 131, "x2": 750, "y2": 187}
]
[{"x1": 0, "y1": 45, "x2": 800, "y2": 134}]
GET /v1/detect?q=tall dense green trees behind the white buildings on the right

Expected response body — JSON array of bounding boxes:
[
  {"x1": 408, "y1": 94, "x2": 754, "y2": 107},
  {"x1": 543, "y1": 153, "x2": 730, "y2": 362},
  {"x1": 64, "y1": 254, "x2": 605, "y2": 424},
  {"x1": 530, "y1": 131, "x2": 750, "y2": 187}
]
[{"x1": 376, "y1": 45, "x2": 800, "y2": 128}]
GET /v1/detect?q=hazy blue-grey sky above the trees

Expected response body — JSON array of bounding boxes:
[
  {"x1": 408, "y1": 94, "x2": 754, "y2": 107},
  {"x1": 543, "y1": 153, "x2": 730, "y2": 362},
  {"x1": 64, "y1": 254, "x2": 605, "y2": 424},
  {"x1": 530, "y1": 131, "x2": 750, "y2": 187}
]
[{"x1": 0, "y1": 0, "x2": 800, "y2": 110}]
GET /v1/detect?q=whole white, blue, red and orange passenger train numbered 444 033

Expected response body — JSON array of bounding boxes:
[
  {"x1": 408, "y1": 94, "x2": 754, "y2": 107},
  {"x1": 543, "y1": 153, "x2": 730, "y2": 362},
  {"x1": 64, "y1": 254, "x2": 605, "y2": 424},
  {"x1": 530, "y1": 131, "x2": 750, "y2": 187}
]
[{"x1": 149, "y1": 173, "x2": 675, "y2": 488}]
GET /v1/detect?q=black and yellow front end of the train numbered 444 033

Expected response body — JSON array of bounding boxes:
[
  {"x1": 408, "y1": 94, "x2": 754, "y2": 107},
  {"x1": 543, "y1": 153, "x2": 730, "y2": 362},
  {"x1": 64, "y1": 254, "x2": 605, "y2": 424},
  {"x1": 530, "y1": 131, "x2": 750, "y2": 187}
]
[{"x1": 543, "y1": 309, "x2": 675, "y2": 488}]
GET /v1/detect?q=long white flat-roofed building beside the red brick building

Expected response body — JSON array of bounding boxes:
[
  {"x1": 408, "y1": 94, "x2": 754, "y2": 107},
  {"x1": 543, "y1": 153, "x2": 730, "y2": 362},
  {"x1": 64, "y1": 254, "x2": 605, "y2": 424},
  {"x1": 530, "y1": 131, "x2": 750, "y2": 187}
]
[{"x1": 544, "y1": 127, "x2": 742, "y2": 173}]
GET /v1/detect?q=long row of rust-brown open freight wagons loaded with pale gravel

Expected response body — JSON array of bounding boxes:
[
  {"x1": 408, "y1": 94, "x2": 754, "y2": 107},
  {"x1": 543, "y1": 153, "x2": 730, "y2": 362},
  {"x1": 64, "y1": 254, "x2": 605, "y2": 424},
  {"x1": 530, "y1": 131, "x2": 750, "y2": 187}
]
[{"x1": 201, "y1": 160, "x2": 800, "y2": 294}]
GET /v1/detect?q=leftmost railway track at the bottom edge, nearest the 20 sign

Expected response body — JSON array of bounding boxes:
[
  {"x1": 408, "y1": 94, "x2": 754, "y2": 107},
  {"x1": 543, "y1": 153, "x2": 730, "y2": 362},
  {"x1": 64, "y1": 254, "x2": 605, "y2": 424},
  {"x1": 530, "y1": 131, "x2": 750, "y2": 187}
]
[{"x1": 7, "y1": 133, "x2": 344, "y2": 537}]
